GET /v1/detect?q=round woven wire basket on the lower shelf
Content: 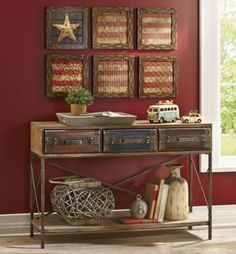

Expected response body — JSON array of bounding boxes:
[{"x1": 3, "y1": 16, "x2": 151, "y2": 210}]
[{"x1": 51, "y1": 178, "x2": 115, "y2": 225}]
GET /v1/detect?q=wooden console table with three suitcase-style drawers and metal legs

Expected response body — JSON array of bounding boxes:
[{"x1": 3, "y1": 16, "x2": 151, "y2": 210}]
[{"x1": 30, "y1": 120, "x2": 212, "y2": 248}]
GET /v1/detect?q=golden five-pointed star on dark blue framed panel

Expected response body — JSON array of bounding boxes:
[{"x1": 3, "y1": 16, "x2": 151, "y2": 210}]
[{"x1": 53, "y1": 13, "x2": 79, "y2": 42}]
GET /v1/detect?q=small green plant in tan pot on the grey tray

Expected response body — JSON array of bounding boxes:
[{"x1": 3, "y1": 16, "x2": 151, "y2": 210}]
[{"x1": 65, "y1": 87, "x2": 93, "y2": 116}]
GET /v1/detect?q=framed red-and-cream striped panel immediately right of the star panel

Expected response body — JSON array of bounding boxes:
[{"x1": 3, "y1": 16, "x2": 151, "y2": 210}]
[{"x1": 92, "y1": 7, "x2": 133, "y2": 49}]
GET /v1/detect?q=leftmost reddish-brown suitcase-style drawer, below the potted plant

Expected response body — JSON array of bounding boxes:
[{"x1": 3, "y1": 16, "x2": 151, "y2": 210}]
[{"x1": 44, "y1": 130, "x2": 101, "y2": 154}]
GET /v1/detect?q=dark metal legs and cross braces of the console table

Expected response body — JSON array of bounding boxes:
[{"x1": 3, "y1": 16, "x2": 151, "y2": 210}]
[{"x1": 30, "y1": 152, "x2": 212, "y2": 248}]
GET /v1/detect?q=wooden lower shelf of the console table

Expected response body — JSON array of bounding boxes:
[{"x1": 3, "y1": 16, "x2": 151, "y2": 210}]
[{"x1": 31, "y1": 213, "x2": 209, "y2": 233}]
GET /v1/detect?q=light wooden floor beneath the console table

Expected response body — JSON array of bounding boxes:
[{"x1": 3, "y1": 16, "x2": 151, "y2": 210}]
[{"x1": 0, "y1": 227, "x2": 236, "y2": 254}]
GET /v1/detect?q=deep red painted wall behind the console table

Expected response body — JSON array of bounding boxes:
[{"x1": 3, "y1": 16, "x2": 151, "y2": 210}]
[{"x1": 0, "y1": 0, "x2": 236, "y2": 213}]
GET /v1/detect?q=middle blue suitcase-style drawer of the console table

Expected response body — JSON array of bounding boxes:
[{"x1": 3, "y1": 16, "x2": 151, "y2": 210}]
[{"x1": 103, "y1": 129, "x2": 157, "y2": 153}]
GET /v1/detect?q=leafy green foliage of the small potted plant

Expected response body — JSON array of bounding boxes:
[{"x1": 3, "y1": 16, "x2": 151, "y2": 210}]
[{"x1": 65, "y1": 87, "x2": 93, "y2": 105}]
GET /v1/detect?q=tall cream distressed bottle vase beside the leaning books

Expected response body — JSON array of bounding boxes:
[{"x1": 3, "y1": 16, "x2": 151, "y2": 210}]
[{"x1": 165, "y1": 164, "x2": 189, "y2": 220}]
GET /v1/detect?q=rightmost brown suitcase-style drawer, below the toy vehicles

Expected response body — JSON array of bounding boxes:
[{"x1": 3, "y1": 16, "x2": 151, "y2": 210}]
[{"x1": 158, "y1": 128, "x2": 211, "y2": 152}]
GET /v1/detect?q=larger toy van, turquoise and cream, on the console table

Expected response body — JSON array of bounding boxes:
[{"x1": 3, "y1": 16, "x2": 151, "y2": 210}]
[{"x1": 147, "y1": 100, "x2": 179, "y2": 123}]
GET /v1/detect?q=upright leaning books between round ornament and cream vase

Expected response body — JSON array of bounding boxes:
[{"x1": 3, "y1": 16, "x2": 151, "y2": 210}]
[{"x1": 144, "y1": 177, "x2": 169, "y2": 222}]
